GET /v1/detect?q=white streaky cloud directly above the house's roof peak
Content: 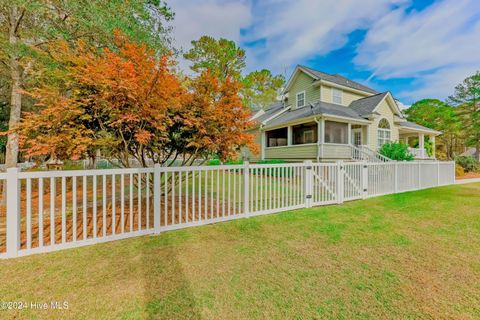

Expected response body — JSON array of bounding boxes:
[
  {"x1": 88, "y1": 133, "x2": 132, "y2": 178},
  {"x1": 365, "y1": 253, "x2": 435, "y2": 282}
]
[{"x1": 244, "y1": 0, "x2": 406, "y2": 69}]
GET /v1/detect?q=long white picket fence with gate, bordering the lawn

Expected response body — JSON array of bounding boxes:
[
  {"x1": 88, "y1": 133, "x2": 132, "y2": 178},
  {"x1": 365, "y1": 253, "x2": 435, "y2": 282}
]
[{"x1": 0, "y1": 161, "x2": 455, "y2": 258}]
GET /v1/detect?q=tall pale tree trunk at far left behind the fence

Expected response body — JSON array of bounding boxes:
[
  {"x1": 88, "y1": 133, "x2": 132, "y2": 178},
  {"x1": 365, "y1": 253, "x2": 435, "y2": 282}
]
[{"x1": 5, "y1": 6, "x2": 22, "y2": 168}]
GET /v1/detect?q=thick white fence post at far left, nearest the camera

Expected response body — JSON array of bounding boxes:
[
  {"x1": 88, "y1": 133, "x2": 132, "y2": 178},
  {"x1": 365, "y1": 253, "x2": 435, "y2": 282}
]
[{"x1": 7, "y1": 168, "x2": 20, "y2": 258}]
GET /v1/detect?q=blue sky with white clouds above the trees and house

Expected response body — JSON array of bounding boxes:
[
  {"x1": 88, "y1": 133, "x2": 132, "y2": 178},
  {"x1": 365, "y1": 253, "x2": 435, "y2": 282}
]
[{"x1": 168, "y1": 0, "x2": 480, "y2": 105}]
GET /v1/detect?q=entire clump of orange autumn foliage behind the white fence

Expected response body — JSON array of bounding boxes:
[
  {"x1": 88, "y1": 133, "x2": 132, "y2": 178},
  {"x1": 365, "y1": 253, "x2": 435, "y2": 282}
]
[{"x1": 19, "y1": 35, "x2": 255, "y2": 167}]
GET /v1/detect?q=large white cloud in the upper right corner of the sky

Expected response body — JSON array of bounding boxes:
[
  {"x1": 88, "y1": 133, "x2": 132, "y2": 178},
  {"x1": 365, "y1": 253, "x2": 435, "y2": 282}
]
[{"x1": 354, "y1": 0, "x2": 480, "y2": 99}]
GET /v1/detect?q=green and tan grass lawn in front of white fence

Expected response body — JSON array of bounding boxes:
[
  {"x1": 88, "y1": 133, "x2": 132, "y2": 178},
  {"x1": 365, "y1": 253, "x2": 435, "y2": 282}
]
[{"x1": 0, "y1": 184, "x2": 480, "y2": 319}]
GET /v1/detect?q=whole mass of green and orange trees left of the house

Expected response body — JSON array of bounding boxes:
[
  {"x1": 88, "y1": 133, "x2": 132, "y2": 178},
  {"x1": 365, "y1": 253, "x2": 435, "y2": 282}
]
[{"x1": 0, "y1": 0, "x2": 284, "y2": 167}]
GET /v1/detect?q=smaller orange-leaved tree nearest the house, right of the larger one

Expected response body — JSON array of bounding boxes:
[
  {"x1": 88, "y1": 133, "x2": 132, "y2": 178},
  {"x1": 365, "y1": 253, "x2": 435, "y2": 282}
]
[{"x1": 168, "y1": 71, "x2": 258, "y2": 165}]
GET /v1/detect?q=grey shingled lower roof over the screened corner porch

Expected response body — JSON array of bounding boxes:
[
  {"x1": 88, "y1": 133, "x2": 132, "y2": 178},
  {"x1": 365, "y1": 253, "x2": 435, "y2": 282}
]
[{"x1": 266, "y1": 102, "x2": 365, "y2": 128}]
